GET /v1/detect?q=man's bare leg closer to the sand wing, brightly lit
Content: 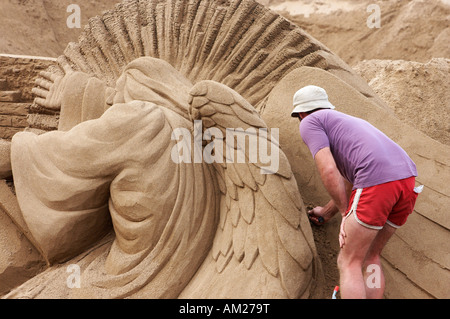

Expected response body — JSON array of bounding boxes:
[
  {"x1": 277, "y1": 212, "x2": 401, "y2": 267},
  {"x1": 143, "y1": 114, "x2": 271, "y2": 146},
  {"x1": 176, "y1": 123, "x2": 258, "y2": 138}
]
[{"x1": 338, "y1": 216, "x2": 379, "y2": 299}]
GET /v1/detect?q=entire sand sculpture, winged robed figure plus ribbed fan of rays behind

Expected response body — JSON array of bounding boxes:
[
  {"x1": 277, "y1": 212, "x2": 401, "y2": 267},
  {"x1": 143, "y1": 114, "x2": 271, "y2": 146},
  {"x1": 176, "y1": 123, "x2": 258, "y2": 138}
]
[{"x1": 1, "y1": 0, "x2": 450, "y2": 298}]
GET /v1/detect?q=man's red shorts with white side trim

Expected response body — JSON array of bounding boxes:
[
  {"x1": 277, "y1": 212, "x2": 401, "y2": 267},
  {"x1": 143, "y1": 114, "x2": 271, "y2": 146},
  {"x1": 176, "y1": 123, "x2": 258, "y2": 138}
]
[{"x1": 346, "y1": 177, "x2": 420, "y2": 229}]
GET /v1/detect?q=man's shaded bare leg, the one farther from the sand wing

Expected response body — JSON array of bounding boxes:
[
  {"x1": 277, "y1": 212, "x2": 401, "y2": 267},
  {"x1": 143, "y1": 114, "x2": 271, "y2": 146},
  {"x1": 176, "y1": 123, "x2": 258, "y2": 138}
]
[{"x1": 363, "y1": 224, "x2": 396, "y2": 299}]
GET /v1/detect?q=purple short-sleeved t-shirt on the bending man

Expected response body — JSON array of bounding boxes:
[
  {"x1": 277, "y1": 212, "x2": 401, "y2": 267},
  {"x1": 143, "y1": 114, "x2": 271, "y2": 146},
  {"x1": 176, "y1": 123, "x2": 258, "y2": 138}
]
[{"x1": 300, "y1": 110, "x2": 417, "y2": 189}]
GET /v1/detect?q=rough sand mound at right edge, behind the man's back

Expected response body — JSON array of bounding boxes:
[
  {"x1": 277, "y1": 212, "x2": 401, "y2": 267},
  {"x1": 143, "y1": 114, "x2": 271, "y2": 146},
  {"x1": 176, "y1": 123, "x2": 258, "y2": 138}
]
[{"x1": 354, "y1": 58, "x2": 450, "y2": 145}]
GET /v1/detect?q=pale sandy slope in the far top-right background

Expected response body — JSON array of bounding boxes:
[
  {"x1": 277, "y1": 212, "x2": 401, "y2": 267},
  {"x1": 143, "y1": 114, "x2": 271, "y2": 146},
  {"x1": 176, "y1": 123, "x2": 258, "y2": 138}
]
[{"x1": 266, "y1": 0, "x2": 450, "y2": 66}]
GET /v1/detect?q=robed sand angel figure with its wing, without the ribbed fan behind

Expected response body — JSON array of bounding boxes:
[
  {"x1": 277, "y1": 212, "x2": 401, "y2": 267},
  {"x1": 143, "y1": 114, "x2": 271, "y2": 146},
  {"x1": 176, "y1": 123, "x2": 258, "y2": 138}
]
[{"x1": 1, "y1": 57, "x2": 319, "y2": 298}]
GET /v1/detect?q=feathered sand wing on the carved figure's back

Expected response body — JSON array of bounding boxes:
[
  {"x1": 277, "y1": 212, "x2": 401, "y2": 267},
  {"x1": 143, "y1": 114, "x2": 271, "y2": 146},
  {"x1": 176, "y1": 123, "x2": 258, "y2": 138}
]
[{"x1": 190, "y1": 81, "x2": 316, "y2": 298}]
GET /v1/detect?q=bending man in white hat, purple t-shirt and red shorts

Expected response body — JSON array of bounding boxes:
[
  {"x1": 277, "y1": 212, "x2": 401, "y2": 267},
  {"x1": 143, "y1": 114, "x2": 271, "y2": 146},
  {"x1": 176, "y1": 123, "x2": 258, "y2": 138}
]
[{"x1": 291, "y1": 85, "x2": 420, "y2": 298}]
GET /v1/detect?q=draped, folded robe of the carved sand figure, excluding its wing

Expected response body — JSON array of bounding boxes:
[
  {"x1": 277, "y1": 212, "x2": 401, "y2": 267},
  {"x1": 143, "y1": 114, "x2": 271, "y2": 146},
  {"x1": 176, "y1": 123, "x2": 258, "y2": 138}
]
[{"x1": 12, "y1": 59, "x2": 217, "y2": 297}]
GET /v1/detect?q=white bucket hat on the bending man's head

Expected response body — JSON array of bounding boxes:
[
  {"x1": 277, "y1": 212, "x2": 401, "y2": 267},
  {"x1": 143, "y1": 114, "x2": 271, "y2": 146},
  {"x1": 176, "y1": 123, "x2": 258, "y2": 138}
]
[{"x1": 291, "y1": 85, "x2": 335, "y2": 117}]
